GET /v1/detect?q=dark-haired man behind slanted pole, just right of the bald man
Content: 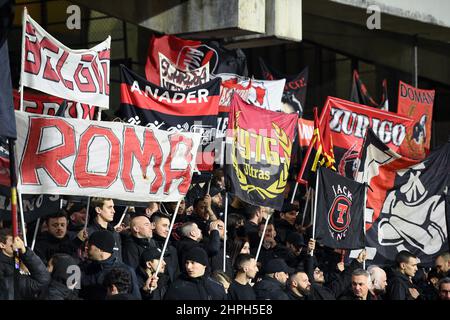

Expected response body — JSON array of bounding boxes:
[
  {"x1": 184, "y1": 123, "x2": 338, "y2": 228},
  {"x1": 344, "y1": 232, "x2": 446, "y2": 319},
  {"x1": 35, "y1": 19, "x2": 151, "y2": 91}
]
[{"x1": 150, "y1": 212, "x2": 180, "y2": 282}]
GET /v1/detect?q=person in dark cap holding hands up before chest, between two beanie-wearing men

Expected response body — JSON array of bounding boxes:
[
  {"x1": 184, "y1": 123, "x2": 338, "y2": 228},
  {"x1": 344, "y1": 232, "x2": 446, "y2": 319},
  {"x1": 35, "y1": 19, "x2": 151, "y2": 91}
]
[{"x1": 136, "y1": 247, "x2": 169, "y2": 300}]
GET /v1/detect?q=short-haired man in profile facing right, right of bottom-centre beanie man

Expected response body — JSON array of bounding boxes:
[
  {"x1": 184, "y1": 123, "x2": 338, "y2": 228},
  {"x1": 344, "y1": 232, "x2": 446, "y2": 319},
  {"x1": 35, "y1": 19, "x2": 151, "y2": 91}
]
[{"x1": 228, "y1": 254, "x2": 258, "y2": 300}]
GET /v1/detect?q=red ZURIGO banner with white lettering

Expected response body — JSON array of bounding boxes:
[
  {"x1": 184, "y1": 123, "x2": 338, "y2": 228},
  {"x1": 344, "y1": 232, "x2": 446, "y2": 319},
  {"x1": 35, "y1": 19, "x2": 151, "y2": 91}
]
[{"x1": 314, "y1": 97, "x2": 413, "y2": 178}]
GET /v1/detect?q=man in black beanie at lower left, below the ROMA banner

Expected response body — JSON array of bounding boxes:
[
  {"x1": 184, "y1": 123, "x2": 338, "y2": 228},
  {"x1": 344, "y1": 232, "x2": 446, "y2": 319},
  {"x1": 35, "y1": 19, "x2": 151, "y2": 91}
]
[{"x1": 80, "y1": 230, "x2": 141, "y2": 300}]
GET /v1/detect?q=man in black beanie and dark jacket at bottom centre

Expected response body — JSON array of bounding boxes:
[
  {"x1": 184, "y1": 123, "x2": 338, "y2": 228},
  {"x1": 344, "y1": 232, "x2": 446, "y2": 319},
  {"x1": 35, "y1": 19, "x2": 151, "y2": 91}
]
[{"x1": 164, "y1": 247, "x2": 227, "y2": 300}]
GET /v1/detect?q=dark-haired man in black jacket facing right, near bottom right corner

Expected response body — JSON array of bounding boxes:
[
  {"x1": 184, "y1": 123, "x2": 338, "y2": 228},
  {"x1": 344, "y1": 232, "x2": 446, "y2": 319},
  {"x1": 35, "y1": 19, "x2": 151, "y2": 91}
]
[{"x1": 387, "y1": 250, "x2": 419, "y2": 300}]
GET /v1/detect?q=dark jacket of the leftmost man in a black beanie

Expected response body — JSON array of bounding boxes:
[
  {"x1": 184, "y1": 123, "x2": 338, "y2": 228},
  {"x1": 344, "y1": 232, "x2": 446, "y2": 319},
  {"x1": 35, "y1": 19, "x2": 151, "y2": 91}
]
[{"x1": 80, "y1": 255, "x2": 141, "y2": 300}]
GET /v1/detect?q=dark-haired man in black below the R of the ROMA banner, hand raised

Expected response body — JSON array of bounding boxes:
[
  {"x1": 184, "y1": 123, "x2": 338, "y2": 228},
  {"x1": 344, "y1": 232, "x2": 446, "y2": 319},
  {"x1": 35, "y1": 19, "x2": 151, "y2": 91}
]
[{"x1": 34, "y1": 211, "x2": 86, "y2": 264}]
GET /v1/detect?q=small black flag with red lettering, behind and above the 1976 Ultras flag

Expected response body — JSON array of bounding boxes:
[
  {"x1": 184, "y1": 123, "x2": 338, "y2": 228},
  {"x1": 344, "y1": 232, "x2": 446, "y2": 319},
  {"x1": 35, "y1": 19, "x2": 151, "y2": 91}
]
[{"x1": 259, "y1": 58, "x2": 308, "y2": 117}]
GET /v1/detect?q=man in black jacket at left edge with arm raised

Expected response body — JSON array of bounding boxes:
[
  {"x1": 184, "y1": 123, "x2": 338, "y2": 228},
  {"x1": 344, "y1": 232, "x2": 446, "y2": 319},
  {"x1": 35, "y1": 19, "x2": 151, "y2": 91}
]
[{"x1": 0, "y1": 229, "x2": 50, "y2": 300}]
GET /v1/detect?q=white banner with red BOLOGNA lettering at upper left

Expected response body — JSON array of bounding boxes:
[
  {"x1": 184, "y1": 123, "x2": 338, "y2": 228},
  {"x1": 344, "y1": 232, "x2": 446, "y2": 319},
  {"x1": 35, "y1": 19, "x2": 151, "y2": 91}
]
[{"x1": 21, "y1": 11, "x2": 111, "y2": 109}]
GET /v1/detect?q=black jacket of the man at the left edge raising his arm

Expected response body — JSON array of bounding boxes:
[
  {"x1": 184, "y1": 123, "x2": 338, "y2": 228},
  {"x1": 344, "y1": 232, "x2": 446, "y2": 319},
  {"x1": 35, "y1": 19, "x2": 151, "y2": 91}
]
[{"x1": 0, "y1": 248, "x2": 50, "y2": 300}]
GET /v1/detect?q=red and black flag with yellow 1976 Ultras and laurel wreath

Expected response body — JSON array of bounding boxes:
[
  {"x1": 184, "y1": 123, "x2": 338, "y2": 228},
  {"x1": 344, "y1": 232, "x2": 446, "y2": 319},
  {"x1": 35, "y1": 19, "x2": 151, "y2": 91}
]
[{"x1": 226, "y1": 95, "x2": 298, "y2": 210}]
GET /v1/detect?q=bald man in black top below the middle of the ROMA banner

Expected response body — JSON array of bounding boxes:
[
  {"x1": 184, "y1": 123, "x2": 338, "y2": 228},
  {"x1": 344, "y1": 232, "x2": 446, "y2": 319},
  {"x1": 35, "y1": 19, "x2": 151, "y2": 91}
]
[{"x1": 122, "y1": 215, "x2": 156, "y2": 269}]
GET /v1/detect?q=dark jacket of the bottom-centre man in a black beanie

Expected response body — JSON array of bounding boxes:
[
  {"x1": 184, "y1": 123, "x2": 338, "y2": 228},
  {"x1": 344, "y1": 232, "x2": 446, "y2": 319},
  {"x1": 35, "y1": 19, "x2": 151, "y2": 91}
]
[{"x1": 164, "y1": 273, "x2": 227, "y2": 300}]
